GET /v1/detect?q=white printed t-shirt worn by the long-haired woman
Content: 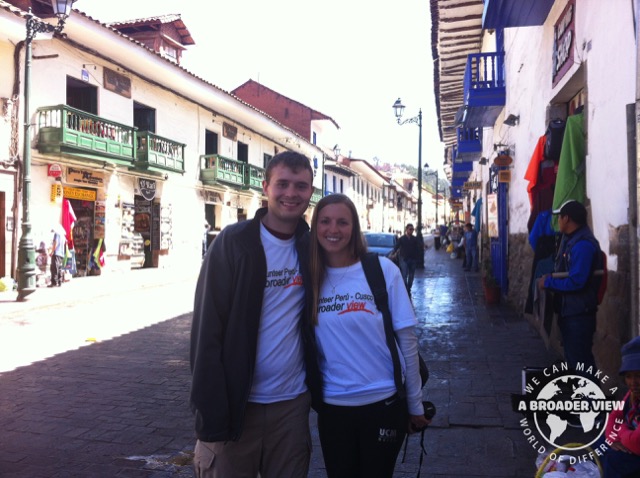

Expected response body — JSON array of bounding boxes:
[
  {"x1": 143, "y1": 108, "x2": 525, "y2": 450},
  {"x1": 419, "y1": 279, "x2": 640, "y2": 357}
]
[{"x1": 316, "y1": 258, "x2": 417, "y2": 406}]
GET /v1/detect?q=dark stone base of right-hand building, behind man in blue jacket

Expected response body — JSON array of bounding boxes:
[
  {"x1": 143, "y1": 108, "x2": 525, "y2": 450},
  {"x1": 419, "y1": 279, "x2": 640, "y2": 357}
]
[{"x1": 506, "y1": 225, "x2": 632, "y2": 378}]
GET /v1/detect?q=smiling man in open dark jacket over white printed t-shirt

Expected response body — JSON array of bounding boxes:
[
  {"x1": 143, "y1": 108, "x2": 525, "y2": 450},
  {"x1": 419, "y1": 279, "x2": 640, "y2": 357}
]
[{"x1": 191, "y1": 152, "x2": 317, "y2": 478}]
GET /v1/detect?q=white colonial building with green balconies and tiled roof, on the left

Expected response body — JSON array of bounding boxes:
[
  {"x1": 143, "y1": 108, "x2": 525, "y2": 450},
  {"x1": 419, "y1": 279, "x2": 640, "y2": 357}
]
[{"x1": 0, "y1": 0, "x2": 323, "y2": 290}]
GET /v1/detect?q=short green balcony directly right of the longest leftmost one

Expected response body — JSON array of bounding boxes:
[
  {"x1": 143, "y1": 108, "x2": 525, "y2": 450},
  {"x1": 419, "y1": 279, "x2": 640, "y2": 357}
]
[{"x1": 134, "y1": 131, "x2": 185, "y2": 173}]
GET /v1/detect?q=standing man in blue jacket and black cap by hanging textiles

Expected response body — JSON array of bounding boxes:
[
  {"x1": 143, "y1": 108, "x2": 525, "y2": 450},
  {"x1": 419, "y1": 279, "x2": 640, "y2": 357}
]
[{"x1": 538, "y1": 200, "x2": 602, "y2": 369}]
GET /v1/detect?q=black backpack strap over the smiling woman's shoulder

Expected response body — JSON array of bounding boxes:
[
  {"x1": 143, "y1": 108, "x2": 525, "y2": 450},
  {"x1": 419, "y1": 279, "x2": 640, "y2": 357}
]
[{"x1": 361, "y1": 252, "x2": 406, "y2": 399}]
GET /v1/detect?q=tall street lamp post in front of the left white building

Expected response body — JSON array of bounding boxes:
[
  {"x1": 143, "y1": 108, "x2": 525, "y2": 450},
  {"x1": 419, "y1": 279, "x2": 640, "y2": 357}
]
[{"x1": 18, "y1": 0, "x2": 75, "y2": 301}]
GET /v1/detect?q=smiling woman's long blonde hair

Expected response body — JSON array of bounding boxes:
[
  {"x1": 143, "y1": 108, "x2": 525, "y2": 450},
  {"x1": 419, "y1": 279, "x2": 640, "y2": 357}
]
[{"x1": 309, "y1": 194, "x2": 367, "y2": 325}]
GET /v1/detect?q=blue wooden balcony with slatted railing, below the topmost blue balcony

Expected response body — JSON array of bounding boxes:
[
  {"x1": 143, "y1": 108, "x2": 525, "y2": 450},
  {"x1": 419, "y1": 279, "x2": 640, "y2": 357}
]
[{"x1": 462, "y1": 52, "x2": 506, "y2": 129}]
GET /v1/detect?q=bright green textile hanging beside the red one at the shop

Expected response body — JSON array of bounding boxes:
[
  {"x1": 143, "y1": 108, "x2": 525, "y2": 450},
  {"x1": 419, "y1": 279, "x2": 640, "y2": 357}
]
[{"x1": 553, "y1": 113, "x2": 587, "y2": 231}]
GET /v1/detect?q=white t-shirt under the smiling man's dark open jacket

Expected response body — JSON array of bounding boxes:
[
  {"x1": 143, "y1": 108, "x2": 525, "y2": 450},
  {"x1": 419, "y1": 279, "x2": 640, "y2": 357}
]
[{"x1": 249, "y1": 225, "x2": 307, "y2": 403}]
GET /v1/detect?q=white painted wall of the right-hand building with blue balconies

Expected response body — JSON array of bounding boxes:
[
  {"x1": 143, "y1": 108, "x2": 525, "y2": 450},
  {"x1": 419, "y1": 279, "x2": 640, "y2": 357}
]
[{"x1": 475, "y1": 0, "x2": 635, "y2": 270}]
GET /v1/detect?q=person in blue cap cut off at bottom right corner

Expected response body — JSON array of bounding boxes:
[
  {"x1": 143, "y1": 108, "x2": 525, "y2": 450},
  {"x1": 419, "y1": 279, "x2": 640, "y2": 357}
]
[{"x1": 603, "y1": 337, "x2": 640, "y2": 478}]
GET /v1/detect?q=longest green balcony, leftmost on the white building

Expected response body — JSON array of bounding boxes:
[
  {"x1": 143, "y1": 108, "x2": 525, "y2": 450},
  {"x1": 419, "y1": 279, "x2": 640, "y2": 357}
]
[{"x1": 36, "y1": 105, "x2": 136, "y2": 163}]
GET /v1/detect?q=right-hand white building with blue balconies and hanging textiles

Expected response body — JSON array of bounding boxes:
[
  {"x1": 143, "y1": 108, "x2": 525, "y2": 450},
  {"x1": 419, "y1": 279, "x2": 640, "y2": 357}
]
[{"x1": 432, "y1": 0, "x2": 639, "y2": 374}]
